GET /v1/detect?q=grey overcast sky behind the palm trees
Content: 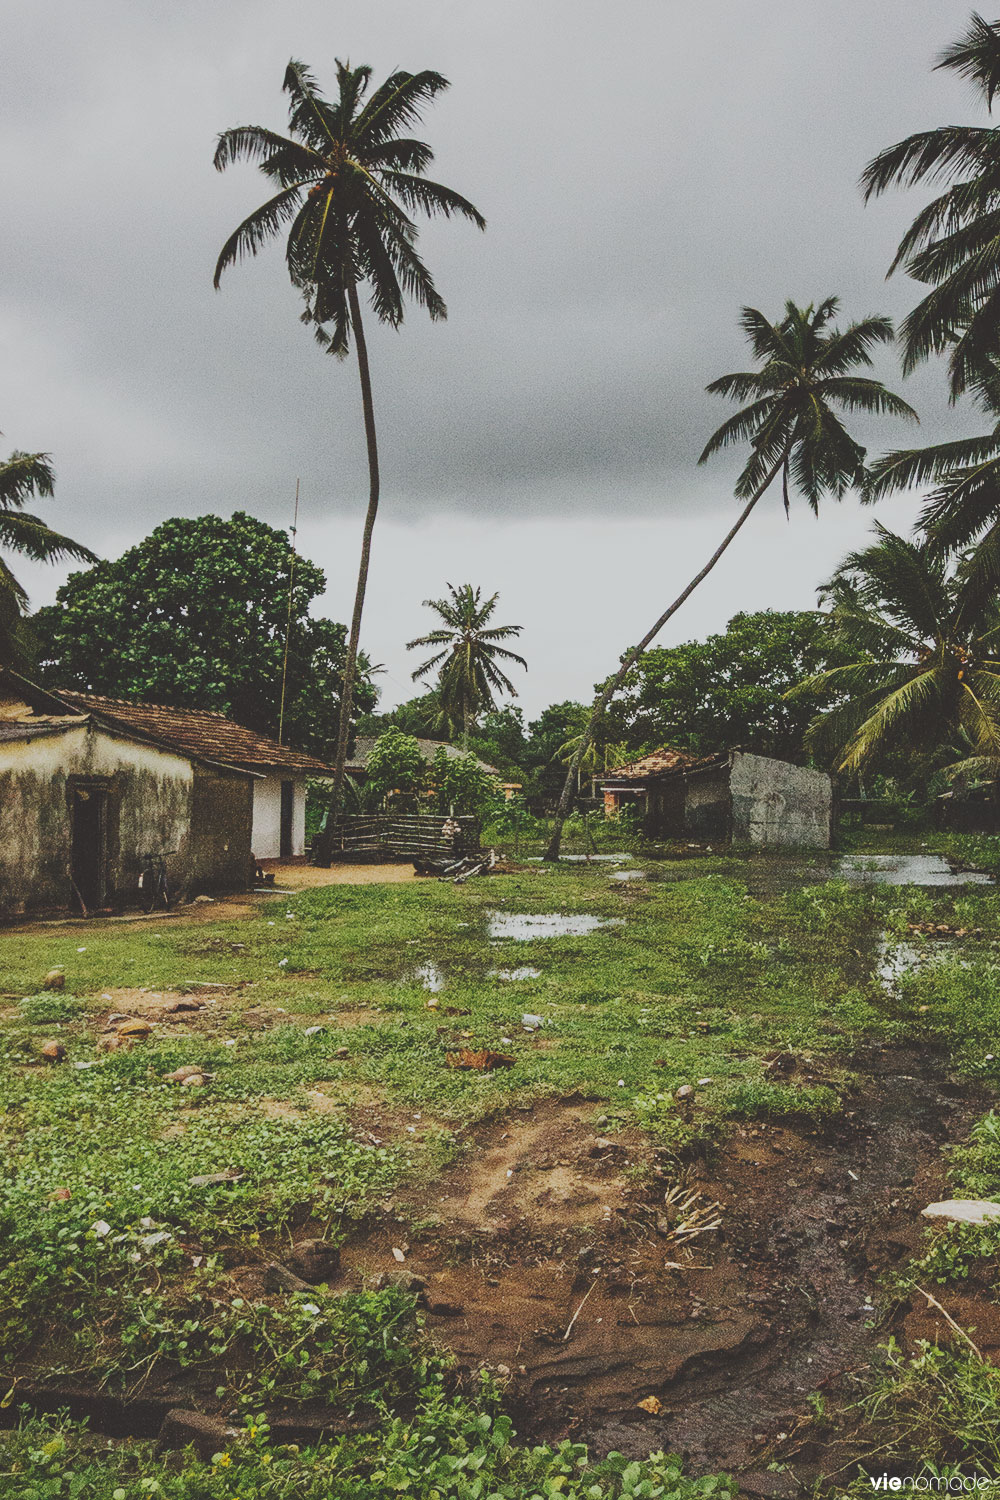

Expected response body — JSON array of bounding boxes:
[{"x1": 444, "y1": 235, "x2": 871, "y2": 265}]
[{"x1": 0, "y1": 0, "x2": 976, "y2": 716}]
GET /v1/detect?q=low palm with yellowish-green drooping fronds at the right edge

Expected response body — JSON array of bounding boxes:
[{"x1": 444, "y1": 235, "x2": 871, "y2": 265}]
[{"x1": 789, "y1": 525, "x2": 1000, "y2": 776}]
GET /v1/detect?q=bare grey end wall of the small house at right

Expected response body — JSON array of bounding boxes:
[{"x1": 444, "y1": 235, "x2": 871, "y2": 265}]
[{"x1": 730, "y1": 752, "x2": 834, "y2": 849}]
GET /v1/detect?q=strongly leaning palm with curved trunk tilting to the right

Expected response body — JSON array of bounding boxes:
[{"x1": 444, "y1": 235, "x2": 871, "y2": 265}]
[{"x1": 546, "y1": 297, "x2": 916, "y2": 860}]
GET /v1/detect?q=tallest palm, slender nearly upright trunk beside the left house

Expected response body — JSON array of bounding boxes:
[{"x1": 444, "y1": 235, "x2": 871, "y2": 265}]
[{"x1": 214, "y1": 60, "x2": 486, "y2": 863}]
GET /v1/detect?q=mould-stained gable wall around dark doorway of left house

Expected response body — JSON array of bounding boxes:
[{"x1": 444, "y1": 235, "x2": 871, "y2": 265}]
[{"x1": 0, "y1": 726, "x2": 193, "y2": 914}]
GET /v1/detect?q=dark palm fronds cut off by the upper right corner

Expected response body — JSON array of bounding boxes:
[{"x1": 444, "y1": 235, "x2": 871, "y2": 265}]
[{"x1": 862, "y1": 14, "x2": 1000, "y2": 398}]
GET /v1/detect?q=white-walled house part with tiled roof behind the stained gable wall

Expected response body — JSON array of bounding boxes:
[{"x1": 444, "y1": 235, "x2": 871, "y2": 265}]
[{"x1": 57, "y1": 690, "x2": 333, "y2": 860}]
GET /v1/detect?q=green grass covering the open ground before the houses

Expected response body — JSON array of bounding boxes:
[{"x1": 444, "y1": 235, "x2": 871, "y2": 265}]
[{"x1": 0, "y1": 852, "x2": 1000, "y2": 1500}]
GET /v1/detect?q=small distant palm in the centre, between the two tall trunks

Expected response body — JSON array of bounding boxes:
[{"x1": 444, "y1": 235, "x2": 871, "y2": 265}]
[{"x1": 406, "y1": 584, "x2": 528, "y2": 746}]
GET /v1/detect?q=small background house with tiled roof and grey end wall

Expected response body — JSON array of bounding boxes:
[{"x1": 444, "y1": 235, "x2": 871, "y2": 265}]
[{"x1": 604, "y1": 747, "x2": 834, "y2": 849}]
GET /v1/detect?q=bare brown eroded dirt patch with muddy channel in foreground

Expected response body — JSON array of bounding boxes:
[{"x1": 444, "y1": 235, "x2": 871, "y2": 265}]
[{"x1": 343, "y1": 1050, "x2": 982, "y2": 1493}]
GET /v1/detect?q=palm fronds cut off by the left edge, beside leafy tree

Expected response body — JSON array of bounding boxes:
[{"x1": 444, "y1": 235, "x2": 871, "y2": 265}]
[{"x1": 0, "y1": 453, "x2": 97, "y2": 666}]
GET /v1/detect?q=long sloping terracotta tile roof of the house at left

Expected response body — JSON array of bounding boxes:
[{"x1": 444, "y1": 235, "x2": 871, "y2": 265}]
[{"x1": 58, "y1": 692, "x2": 333, "y2": 776}]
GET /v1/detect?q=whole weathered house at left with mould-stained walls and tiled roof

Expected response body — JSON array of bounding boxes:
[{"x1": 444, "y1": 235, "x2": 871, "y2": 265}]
[{"x1": 0, "y1": 672, "x2": 330, "y2": 915}]
